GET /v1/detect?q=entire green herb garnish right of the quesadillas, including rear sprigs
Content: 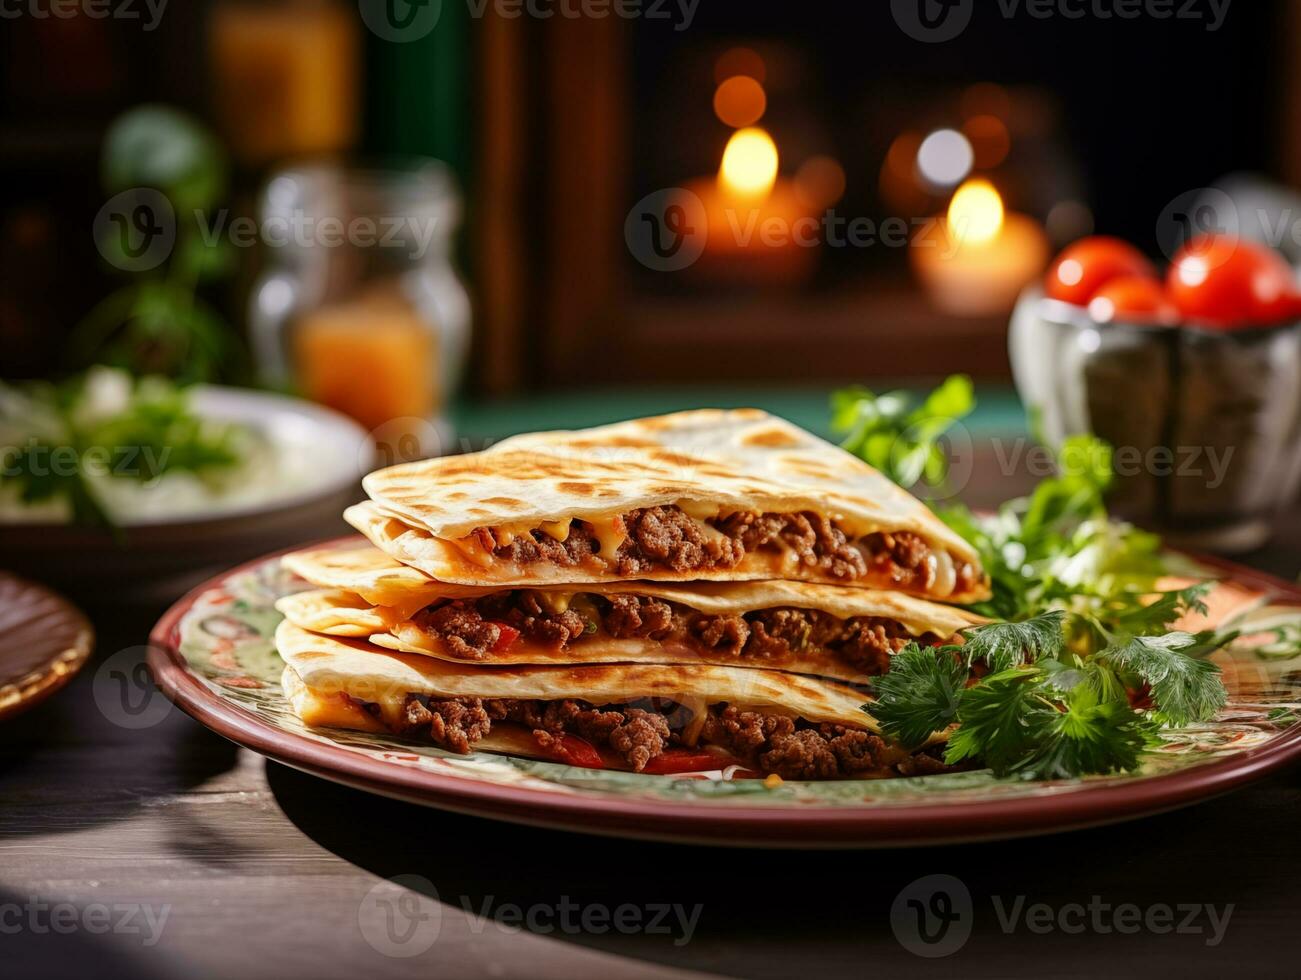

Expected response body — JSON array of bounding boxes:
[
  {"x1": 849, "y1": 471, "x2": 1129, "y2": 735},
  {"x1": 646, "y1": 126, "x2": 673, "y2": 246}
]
[{"x1": 833, "y1": 377, "x2": 1236, "y2": 780}]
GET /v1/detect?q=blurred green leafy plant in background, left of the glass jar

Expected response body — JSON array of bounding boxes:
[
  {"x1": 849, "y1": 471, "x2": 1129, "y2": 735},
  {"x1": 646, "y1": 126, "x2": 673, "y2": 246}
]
[{"x1": 68, "y1": 105, "x2": 245, "y2": 383}]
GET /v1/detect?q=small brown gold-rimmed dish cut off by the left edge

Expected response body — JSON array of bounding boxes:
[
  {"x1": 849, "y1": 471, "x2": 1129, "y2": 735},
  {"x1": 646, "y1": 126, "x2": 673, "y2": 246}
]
[{"x1": 0, "y1": 571, "x2": 94, "y2": 718}]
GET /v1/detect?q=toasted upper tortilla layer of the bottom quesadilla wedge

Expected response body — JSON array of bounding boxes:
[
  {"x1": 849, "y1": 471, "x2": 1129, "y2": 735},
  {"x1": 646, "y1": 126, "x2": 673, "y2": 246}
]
[{"x1": 276, "y1": 619, "x2": 879, "y2": 731}]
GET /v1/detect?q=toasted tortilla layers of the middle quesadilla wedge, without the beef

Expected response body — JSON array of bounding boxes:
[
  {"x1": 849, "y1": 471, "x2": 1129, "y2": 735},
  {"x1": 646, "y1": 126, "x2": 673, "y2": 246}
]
[{"x1": 276, "y1": 553, "x2": 982, "y2": 683}]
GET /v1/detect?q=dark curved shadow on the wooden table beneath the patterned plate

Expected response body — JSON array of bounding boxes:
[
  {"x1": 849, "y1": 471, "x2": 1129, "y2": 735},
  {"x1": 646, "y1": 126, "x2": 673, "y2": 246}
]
[{"x1": 267, "y1": 763, "x2": 1301, "y2": 976}]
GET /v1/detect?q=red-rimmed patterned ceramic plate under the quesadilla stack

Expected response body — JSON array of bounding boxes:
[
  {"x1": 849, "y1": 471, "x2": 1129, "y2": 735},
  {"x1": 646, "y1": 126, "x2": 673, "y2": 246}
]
[{"x1": 150, "y1": 541, "x2": 1301, "y2": 847}]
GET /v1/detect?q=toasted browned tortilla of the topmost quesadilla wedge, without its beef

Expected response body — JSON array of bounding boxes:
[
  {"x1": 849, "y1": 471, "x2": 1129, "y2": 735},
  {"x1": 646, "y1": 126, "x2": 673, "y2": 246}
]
[{"x1": 356, "y1": 410, "x2": 985, "y2": 601}]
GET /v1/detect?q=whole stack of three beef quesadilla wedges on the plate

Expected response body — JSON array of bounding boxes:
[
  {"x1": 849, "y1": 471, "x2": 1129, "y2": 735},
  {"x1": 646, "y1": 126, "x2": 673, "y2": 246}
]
[{"x1": 277, "y1": 411, "x2": 986, "y2": 778}]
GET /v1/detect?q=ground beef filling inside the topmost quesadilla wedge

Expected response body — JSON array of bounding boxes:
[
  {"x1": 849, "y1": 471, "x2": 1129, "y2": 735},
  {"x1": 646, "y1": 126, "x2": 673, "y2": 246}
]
[{"x1": 475, "y1": 506, "x2": 978, "y2": 591}]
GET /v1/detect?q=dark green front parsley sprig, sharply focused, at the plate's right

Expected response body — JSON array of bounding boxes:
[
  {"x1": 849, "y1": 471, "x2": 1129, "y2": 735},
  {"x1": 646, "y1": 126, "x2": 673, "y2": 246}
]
[{"x1": 863, "y1": 610, "x2": 1232, "y2": 778}]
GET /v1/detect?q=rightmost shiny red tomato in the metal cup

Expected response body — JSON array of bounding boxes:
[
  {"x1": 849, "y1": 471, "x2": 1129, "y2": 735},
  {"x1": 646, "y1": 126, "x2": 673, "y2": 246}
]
[{"x1": 1166, "y1": 234, "x2": 1298, "y2": 329}]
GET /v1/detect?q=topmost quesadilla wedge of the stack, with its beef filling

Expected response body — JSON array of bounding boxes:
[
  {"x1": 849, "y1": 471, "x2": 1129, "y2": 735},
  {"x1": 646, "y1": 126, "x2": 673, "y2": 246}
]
[{"x1": 345, "y1": 410, "x2": 987, "y2": 603}]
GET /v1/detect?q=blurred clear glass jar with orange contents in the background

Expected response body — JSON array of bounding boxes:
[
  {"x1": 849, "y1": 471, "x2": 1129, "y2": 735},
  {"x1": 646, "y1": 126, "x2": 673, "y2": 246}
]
[{"x1": 250, "y1": 160, "x2": 470, "y2": 458}]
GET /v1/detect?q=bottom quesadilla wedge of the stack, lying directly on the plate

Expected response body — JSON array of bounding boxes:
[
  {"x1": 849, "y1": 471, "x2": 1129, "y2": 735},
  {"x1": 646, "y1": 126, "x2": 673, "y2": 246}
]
[{"x1": 276, "y1": 621, "x2": 945, "y2": 780}]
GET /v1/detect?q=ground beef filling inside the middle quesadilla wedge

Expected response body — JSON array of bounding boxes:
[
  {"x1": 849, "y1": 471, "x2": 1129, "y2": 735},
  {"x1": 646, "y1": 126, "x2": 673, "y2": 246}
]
[{"x1": 415, "y1": 590, "x2": 939, "y2": 675}]
